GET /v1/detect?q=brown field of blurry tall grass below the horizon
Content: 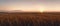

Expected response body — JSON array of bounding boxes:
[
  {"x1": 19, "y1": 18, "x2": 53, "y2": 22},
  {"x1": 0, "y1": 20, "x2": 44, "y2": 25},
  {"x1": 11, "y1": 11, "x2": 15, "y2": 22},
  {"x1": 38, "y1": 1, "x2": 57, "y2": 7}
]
[{"x1": 0, "y1": 13, "x2": 60, "y2": 26}]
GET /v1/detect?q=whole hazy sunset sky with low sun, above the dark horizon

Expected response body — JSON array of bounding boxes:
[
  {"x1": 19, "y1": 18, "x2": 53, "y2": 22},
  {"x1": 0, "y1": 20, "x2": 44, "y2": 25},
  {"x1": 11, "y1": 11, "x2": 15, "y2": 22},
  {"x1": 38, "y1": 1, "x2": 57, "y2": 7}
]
[{"x1": 0, "y1": 0, "x2": 60, "y2": 12}]
